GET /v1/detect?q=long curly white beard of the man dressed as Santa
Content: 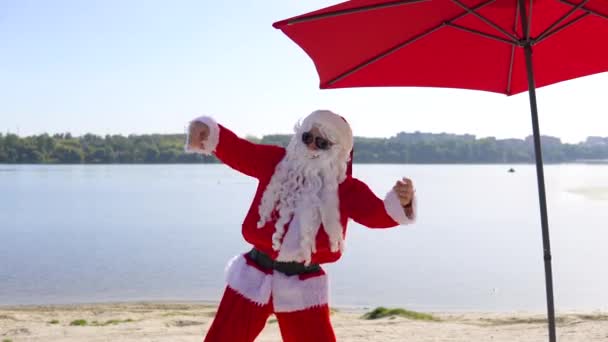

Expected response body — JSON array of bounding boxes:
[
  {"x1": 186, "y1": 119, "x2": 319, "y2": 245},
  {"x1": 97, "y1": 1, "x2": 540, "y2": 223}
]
[{"x1": 258, "y1": 134, "x2": 347, "y2": 264}]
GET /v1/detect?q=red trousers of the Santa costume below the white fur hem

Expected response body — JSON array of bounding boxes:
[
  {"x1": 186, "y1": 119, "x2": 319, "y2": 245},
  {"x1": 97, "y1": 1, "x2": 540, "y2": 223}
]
[{"x1": 205, "y1": 287, "x2": 336, "y2": 342}]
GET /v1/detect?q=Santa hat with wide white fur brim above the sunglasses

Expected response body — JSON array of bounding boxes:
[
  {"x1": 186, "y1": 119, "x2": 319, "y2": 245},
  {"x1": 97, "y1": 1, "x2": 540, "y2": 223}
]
[{"x1": 302, "y1": 110, "x2": 354, "y2": 175}]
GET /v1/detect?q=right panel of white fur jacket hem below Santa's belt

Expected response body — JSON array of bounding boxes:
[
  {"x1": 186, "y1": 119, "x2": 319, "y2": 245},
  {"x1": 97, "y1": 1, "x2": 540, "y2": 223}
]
[{"x1": 272, "y1": 271, "x2": 329, "y2": 312}]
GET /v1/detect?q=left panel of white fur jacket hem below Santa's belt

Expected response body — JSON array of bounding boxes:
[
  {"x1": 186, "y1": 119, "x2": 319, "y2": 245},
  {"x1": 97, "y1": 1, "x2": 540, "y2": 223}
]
[{"x1": 226, "y1": 255, "x2": 272, "y2": 305}]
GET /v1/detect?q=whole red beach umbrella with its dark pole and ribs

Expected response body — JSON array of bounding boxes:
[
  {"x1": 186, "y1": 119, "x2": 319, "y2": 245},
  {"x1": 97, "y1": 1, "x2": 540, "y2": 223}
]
[{"x1": 274, "y1": 0, "x2": 608, "y2": 341}]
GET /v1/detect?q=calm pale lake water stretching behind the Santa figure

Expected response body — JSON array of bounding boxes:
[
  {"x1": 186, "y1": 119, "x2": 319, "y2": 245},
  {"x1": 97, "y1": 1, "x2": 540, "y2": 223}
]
[{"x1": 0, "y1": 164, "x2": 608, "y2": 311}]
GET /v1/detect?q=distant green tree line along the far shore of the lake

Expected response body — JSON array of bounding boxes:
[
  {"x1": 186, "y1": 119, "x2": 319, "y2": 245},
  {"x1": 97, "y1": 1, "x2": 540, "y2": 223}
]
[{"x1": 0, "y1": 132, "x2": 608, "y2": 164}]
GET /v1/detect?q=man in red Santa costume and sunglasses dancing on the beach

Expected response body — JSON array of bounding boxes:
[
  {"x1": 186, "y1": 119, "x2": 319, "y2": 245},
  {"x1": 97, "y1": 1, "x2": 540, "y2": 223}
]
[{"x1": 186, "y1": 110, "x2": 416, "y2": 342}]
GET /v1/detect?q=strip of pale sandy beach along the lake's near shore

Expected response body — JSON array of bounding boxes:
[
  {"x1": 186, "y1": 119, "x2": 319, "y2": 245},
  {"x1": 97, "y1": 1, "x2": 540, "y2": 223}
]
[{"x1": 0, "y1": 303, "x2": 608, "y2": 342}]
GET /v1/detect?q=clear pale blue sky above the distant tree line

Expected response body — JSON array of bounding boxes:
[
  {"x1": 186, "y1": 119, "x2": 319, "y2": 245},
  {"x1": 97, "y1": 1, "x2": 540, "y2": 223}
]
[{"x1": 0, "y1": 0, "x2": 608, "y2": 142}]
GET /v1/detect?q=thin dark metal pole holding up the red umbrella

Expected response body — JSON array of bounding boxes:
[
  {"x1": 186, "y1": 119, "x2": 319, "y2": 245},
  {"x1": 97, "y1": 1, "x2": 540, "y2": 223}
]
[{"x1": 524, "y1": 42, "x2": 556, "y2": 342}]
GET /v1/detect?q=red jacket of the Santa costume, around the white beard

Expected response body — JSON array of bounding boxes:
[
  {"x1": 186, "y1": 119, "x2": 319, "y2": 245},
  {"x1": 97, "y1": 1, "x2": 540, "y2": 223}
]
[{"x1": 197, "y1": 120, "x2": 413, "y2": 264}]
